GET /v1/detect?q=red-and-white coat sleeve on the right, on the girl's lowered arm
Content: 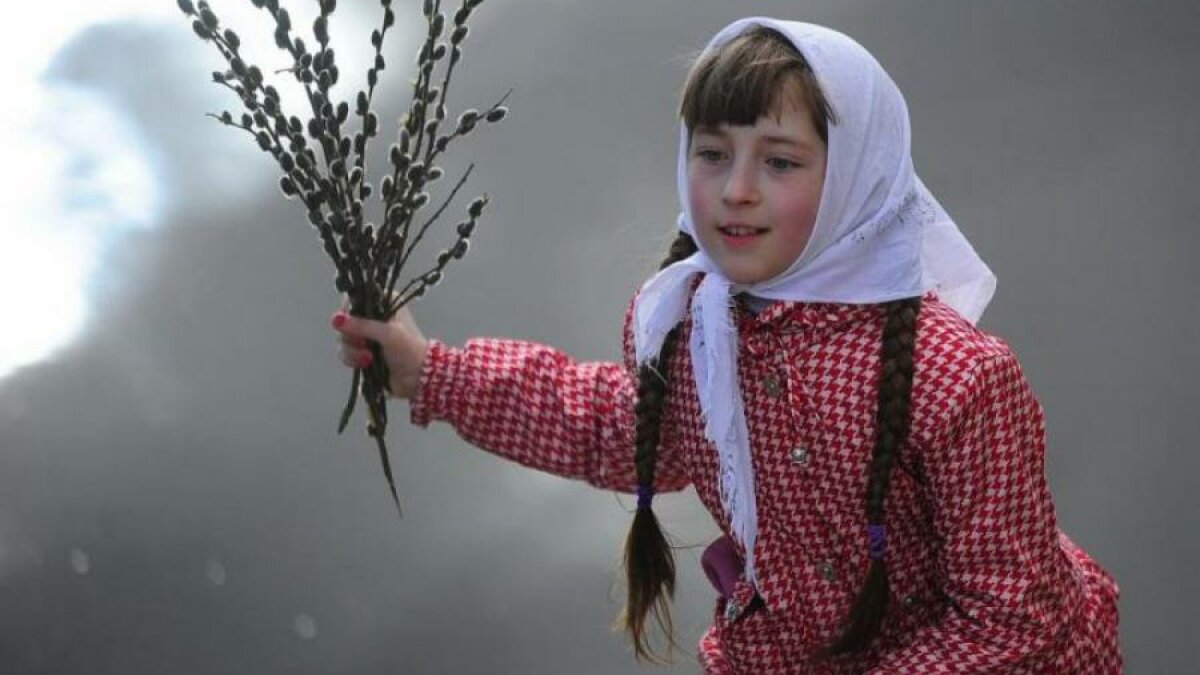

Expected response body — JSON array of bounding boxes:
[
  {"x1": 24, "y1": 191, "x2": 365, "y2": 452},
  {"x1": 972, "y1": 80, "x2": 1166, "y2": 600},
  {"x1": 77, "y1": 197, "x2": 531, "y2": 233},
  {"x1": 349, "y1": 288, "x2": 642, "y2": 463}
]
[{"x1": 869, "y1": 350, "x2": 1073, "y2": 675}]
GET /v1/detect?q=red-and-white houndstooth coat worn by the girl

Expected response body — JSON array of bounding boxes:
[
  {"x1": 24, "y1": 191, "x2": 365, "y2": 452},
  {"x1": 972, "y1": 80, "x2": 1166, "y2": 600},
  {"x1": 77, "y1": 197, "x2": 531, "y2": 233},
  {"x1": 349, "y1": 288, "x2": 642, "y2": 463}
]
[{"x1": 412, "y1": 294, "x2": 1122, "y2": 675}]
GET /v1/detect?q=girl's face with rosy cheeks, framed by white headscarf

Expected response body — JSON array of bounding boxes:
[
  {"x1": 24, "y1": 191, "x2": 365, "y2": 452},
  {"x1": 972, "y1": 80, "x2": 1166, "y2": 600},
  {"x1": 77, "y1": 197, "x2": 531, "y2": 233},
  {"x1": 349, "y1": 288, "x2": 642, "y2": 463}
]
[{"x1": 688, "y1": 92, "x2": 826, "y2": 283}]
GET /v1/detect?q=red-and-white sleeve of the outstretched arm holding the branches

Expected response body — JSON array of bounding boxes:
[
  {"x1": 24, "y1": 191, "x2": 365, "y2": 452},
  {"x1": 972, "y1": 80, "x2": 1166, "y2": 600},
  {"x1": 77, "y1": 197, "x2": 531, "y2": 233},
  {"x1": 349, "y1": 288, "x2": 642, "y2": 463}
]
[{"x1": 410, "y1": 296, "x2": 689, "y2": 492}]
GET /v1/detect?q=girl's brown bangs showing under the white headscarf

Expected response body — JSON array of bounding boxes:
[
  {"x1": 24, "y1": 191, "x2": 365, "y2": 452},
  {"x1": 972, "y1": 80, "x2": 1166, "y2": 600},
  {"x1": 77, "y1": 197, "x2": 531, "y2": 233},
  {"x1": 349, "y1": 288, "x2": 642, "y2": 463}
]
[{"x1": 679, "y1": 25, "x2": 833, "y2": 143}]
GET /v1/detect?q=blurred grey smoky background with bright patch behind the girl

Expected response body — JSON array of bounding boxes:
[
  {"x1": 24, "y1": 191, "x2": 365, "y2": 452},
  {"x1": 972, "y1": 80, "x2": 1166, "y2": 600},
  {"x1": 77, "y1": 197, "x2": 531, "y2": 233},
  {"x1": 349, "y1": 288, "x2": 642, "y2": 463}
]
[{"x1": 0, "y1": 0, "x2": 1200, "y2": 675}]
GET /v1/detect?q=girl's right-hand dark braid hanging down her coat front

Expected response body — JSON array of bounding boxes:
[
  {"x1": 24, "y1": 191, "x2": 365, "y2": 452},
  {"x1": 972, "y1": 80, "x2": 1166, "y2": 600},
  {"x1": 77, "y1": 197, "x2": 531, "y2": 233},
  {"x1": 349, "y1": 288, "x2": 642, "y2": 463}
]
[{"x1": 823, "y1": 298, "x2": 920, "y2": 656}]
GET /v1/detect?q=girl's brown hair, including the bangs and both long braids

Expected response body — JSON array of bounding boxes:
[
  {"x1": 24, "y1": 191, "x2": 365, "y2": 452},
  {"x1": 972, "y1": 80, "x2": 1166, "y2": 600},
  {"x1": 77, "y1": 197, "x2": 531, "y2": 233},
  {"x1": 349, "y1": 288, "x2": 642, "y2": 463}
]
[{"x1": 620, "y1": 25, "x2": 919, "y2": 663}]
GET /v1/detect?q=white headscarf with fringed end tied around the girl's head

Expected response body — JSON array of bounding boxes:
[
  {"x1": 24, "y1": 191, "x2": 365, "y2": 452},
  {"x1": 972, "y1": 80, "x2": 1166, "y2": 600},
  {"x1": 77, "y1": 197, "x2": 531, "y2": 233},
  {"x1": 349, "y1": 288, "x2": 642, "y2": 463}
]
[{"x1": 634, "y1": 17, "x2": 996, "y2": 583}]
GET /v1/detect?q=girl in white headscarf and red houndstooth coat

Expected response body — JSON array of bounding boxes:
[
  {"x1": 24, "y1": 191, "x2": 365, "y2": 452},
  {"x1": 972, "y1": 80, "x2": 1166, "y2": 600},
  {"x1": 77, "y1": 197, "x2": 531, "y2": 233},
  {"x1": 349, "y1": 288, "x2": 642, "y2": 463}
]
[{"x1": 334, "y1": 18, "x2": 1122, "y2": 675}]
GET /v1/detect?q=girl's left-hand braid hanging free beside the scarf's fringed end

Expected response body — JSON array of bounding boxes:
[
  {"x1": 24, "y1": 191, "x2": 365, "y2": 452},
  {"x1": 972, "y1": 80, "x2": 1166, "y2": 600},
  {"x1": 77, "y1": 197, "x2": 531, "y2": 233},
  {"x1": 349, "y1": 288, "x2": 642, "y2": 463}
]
[{"x1": 620, "y1": 228, "x2": 697, "y2": 663}]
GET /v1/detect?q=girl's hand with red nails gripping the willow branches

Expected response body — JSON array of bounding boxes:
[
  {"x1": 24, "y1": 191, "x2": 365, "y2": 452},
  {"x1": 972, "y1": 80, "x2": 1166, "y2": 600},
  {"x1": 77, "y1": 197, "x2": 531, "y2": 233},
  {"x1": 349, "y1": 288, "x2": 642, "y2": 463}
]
[{"x1": 330, "y1": 305, "x2": 430, "y2": 399}]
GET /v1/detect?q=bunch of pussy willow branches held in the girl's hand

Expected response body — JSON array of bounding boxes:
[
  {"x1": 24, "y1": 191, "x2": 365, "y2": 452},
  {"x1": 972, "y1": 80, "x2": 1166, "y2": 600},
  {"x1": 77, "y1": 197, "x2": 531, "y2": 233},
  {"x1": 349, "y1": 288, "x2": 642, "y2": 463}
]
[{"x1": 176, "y1": 0, "x2": 508, "y2": 509}]
